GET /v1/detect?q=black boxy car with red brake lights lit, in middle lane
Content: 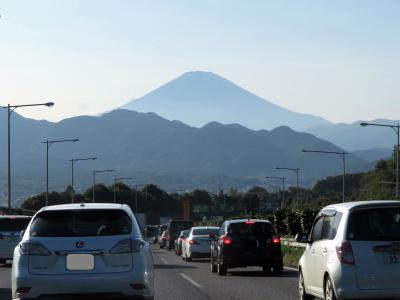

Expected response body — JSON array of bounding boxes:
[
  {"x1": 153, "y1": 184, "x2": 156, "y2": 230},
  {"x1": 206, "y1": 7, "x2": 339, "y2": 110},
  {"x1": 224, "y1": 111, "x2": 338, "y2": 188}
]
[{"x1": 211, "y1": 219, "x2": 283, "y2": 275}]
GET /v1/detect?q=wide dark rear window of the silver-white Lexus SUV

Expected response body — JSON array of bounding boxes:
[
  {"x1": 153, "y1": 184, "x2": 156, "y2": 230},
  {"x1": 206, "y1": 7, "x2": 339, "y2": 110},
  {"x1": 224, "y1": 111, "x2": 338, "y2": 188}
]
[{"x1": 30, "y1": 209, "x2": 132, "y2": 237}]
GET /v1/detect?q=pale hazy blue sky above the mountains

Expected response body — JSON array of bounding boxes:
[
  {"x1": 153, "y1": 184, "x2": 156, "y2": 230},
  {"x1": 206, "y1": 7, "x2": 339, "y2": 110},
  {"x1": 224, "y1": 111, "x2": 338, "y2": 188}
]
[{"x1": 0, "y1": 0, "x2": 400, "y2": 122}]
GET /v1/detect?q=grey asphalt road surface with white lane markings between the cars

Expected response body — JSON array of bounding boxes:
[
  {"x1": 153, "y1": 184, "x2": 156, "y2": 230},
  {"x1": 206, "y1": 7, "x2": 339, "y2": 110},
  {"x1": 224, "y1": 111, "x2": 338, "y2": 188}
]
[{"x1": 0, "y1": 250, "x2": 298, "y2": 300}]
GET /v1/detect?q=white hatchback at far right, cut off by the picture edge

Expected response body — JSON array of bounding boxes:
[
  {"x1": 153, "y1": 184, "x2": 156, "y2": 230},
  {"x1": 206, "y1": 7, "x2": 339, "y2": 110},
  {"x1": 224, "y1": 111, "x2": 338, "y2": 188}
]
[{"x1": 296, "y1": 201, "x2": 400, "y2": 300}]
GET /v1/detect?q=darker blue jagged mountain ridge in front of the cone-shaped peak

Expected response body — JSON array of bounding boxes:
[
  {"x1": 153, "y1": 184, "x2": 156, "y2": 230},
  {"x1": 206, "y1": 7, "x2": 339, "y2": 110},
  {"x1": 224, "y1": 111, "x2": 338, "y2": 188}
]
[{"x1": 0, "y1": 110, "x2": 369, "y2": 206}]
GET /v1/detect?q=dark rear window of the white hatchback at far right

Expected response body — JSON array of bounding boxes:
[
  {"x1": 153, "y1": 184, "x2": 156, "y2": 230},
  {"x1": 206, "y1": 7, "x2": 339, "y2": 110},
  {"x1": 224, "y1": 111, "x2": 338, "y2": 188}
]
[{"x1": 347, "y1": 207, "x2": 400, "y2": 241}]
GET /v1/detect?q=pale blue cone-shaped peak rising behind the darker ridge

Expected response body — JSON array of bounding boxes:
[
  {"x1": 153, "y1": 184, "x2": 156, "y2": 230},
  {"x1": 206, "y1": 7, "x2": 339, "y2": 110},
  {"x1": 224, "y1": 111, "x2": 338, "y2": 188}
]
[{"x1": 121, "y1": 71, "x2": 330, "y2": 130}]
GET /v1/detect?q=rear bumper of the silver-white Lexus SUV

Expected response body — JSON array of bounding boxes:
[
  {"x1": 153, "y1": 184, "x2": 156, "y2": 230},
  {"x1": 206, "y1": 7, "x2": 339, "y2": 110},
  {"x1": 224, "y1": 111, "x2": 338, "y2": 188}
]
[{"x1": 12, "y1": 264, "x2": 154, "y2": 299}]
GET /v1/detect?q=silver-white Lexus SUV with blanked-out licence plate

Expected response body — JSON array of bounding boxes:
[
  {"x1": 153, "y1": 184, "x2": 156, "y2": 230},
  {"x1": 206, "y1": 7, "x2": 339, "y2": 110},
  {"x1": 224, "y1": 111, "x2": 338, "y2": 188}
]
[{"x1": 11, "y1": 203, "x2": 154, "y2": 299}]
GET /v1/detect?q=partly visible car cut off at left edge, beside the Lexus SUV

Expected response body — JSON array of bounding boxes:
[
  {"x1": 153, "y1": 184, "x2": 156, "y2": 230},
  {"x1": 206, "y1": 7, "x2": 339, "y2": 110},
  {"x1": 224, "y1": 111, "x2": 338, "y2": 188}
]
[{"x1": 0, "y1": 216, "x2": 32, "y2": 264}]
